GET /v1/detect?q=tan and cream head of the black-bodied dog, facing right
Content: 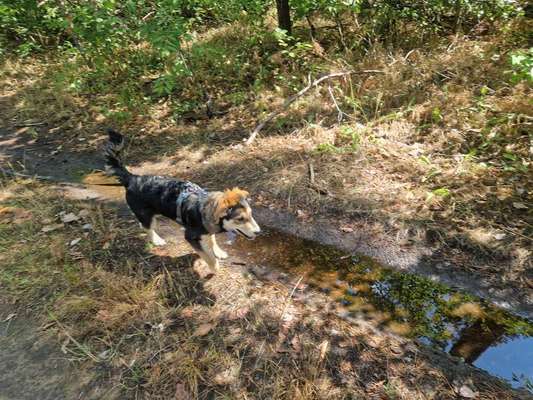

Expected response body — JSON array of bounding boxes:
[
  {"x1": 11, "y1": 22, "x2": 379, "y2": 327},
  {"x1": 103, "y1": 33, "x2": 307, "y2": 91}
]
[{"x1": 206, "y1": 188, "x2": 261, "y2": 239}]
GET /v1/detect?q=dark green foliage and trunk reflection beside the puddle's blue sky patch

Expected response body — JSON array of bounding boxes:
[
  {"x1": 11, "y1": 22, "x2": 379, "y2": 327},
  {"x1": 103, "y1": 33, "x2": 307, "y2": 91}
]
[{"x1": 356, "y1": 270, "x2": 533, "y2": 363}]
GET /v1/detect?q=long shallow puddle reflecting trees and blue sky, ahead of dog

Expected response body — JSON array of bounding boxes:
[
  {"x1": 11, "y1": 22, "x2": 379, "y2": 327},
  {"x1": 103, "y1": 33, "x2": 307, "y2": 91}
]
[{"x1": 232, "y1": 231, "x2": 533, "y2": 391}]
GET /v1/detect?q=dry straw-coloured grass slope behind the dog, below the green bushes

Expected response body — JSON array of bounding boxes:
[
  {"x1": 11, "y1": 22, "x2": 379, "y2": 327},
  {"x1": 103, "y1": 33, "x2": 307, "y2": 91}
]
[{"x1": 0, "y1": 17, "x2": 533, "y2": 302}]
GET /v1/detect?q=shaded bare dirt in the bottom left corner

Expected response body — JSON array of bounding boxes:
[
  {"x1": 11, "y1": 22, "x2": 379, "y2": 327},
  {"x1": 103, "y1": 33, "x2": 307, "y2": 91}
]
[{"x1": 0, "y1": 304, "x2": 119, "y2": 400}]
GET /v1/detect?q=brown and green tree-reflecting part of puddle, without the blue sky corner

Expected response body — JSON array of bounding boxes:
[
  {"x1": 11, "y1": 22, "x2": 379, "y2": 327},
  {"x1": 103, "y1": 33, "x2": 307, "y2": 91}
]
[{"x1": 234, "y1": 232, "x2": 533, "y2": 362}]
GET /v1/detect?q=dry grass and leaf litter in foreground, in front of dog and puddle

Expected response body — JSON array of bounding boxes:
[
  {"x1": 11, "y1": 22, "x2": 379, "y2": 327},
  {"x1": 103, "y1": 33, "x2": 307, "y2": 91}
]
[{"x1": 0, "y1": 181, "x2": 517, "y2": 399}]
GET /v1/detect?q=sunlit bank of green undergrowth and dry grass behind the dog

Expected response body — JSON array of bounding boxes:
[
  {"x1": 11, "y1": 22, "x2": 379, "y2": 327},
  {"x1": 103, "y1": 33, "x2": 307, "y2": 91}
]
[{"x1": 0, "y1": 0, "x2": 533, "y2": 296}]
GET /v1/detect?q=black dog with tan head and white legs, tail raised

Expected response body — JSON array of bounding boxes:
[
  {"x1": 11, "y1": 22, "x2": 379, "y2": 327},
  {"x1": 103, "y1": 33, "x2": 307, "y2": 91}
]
[{"x1": 104, "y1": 129, "x2": 261, "y2": 273}]
